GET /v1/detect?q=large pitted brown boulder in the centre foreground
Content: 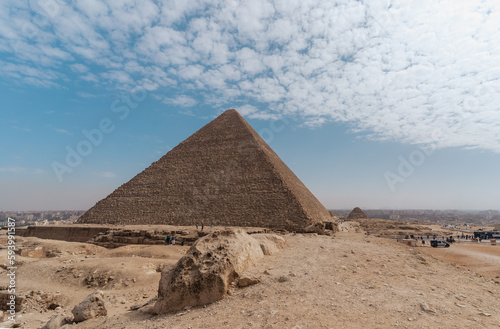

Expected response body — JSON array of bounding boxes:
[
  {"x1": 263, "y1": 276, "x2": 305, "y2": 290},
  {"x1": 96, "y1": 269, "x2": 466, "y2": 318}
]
[{"x1": 152, "y1": 230, "x2": 286, "y2": 314}]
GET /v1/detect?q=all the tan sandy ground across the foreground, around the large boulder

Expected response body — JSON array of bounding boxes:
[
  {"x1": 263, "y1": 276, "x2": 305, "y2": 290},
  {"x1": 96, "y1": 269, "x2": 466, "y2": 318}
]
[{"x1": 0, "y1": 228, "x2": 500, "y2": 329}]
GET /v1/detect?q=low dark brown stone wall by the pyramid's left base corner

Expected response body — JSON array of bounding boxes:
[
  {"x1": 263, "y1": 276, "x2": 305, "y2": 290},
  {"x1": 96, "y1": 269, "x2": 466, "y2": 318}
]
[{"x1": 22, "y1": 225, "x2": 110, "y2": 242}]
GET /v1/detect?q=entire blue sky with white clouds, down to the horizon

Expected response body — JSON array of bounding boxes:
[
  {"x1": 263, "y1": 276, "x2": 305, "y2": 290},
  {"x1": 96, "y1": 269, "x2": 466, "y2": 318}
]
[{"x1": 0, "y1": 0, "x2": 500, "y2": 210}]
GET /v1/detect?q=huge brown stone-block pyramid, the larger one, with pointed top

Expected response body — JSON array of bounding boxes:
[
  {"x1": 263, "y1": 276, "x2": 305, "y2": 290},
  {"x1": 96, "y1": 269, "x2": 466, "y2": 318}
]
[{"x1": 78, "y1": 110, "x2": 331, "y2": 230}]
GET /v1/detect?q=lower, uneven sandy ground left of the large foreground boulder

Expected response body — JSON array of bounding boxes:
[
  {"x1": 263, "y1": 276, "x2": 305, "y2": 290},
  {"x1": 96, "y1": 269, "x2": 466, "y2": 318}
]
[{"x1": 0, "y1": 237, "x2": 189, "y2": 328}]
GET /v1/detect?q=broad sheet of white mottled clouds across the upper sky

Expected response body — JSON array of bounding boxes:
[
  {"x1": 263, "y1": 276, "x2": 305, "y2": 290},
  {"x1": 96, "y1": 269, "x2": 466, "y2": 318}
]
[{"x1": 0, "y1": 0, "x2": 500, "y2": 153}]
